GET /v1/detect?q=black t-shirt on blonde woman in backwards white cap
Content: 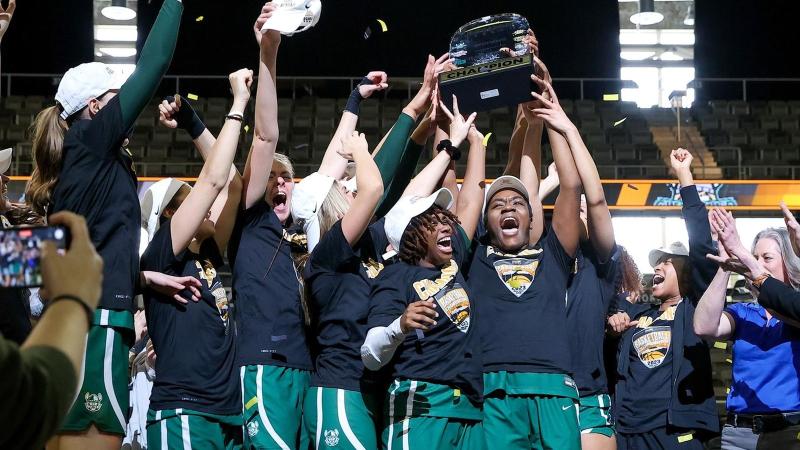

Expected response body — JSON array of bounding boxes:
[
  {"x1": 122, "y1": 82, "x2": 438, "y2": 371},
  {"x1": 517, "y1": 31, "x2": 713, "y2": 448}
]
[{"x1": 304, "y1": 220, "x2": 388, "y2": 391}]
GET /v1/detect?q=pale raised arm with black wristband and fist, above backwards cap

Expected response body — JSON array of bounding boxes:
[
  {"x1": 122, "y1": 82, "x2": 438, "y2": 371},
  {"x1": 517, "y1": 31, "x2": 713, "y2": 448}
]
[{"x1": 318, "y1": 72, "x2": 389, "y2": 180}]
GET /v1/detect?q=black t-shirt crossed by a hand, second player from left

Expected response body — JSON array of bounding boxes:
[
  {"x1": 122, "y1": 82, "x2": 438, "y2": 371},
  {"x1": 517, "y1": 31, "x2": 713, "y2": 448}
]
[{"x1": 142, "y1": 221, "x2": 242, "y2": 415}]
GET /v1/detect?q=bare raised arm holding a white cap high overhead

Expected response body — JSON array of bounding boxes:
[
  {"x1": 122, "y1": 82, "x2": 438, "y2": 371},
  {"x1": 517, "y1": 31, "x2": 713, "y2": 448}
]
[{"x1": 242, "y1": 8, "x2": 281, "y2": 209}]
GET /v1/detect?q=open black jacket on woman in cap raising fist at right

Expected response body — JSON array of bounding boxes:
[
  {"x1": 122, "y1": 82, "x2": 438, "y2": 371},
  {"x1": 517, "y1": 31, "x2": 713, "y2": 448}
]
[{"x1": 616, "y1": 185, "x2": 719, "y2": 433}]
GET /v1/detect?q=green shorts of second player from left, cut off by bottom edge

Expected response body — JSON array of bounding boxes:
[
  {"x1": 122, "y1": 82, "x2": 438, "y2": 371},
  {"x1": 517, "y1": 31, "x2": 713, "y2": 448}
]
[{"x1": 147, "y1": 409, "x2": 242, "y2": 450}]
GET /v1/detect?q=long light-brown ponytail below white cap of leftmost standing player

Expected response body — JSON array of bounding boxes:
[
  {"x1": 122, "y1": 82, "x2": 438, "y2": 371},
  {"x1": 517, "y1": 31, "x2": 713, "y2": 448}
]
[{"x1": 25, "y1": 106, "x2": 69, "y2": 216}]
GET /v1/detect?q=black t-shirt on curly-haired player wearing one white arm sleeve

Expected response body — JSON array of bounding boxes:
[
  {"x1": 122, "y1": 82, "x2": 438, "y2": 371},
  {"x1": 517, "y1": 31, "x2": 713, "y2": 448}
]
[{"x1": 369, "y1": 229, "x2": 483, "y2": 403}]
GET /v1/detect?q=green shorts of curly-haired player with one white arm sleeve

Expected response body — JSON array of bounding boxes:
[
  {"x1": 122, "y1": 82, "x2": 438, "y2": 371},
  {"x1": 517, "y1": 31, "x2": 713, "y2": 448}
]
[{"x1": 383, "y1": 380, "x2": 485, "y2": 450}]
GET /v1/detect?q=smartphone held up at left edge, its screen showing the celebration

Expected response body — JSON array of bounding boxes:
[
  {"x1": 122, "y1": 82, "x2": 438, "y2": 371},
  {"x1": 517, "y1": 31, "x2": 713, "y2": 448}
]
[{"x1": 0, "y1": 226, "x2": 69, "y2": 288}]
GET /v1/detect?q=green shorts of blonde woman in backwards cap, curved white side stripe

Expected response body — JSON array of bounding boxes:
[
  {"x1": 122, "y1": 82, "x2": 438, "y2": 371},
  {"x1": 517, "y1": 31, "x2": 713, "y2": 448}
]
[{"x1": 303, "y1": 386, "x2": 380, "y2": 450}]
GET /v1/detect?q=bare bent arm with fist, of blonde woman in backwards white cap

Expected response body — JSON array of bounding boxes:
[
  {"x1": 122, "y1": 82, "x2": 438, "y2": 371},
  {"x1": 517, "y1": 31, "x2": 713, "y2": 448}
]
[{"x1": 342, "y1": 131, "x2": 383, "y2": 246}]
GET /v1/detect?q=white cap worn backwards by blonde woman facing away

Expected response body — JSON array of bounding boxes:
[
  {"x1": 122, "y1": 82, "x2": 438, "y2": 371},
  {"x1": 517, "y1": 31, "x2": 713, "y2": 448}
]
[{"x1": 292, "y1": 172, "x2": 335, "y2": 252}]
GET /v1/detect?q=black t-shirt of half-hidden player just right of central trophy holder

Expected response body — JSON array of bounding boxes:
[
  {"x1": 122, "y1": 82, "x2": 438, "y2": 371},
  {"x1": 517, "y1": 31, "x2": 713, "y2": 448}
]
[{"x1": 567, "y1": 242, "x2": 619, "y2": 397}]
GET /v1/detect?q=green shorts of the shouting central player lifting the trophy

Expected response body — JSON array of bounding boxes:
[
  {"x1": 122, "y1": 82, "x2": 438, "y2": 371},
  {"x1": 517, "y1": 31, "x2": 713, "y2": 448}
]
[{"x1": 483, "y1": 372, "x2": 581, "y2": 450}]
